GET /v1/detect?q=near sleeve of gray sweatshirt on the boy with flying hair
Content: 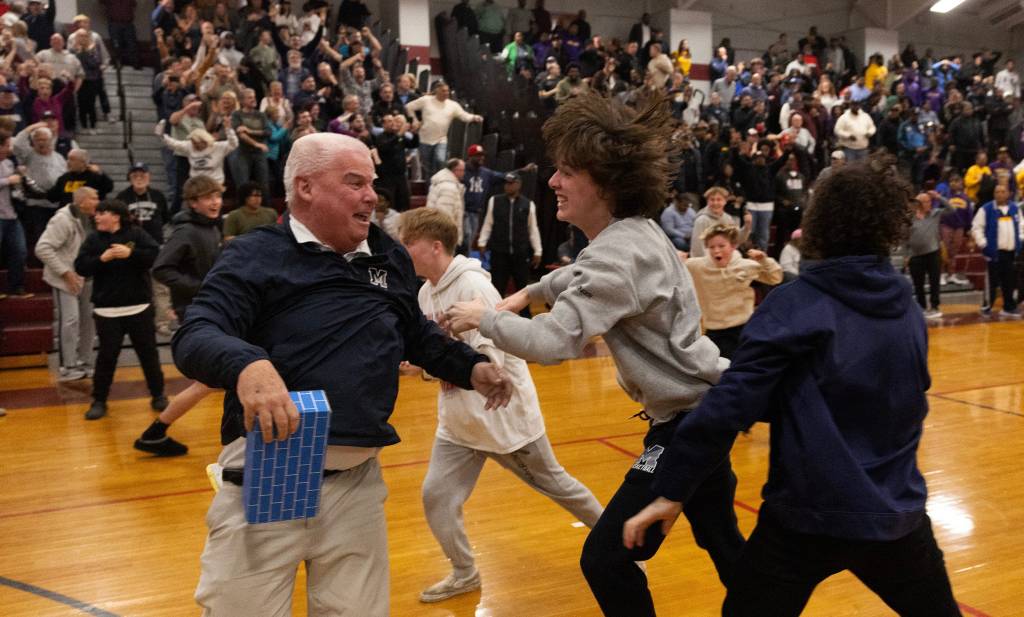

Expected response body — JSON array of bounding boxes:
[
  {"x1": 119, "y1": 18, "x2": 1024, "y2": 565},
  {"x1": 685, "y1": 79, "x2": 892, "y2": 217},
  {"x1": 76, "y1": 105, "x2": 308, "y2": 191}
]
[{"x1": 480, "y1": 255, "x2": 640, "y2": 364}]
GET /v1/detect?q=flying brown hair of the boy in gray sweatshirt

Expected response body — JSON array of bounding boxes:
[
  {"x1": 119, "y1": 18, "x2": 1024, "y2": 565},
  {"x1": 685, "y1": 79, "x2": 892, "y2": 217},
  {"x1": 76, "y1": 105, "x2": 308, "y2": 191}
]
[{"x1": 543, "y1": 94, "x2": 678, "y2": 218}]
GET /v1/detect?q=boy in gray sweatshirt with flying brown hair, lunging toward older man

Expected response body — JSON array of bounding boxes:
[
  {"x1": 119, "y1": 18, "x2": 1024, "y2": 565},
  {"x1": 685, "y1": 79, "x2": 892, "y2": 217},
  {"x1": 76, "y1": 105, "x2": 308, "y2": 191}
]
[{"x1": 445, "y1": 96, "x2": 744, "y2": 617}]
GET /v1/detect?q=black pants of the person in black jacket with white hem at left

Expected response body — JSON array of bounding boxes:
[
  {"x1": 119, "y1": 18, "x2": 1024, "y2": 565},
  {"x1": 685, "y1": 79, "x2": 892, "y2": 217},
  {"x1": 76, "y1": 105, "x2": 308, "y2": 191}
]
[{"x1": 92, "y1": 304, "x2": 164, "y2": 401}]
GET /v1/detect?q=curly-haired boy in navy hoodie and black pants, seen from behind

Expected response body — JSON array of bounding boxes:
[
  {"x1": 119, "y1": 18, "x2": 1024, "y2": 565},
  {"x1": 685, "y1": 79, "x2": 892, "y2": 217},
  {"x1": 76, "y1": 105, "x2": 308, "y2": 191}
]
[{"x1": 623, "y1": 156, "x2": 961, "y2": 617}]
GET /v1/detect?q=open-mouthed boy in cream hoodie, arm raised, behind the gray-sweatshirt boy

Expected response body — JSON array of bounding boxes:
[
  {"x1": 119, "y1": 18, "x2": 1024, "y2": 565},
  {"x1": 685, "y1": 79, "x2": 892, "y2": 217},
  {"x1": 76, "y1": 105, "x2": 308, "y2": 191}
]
[{"x1": 686, "y1": 224, "x2": 782, "y2": 358}]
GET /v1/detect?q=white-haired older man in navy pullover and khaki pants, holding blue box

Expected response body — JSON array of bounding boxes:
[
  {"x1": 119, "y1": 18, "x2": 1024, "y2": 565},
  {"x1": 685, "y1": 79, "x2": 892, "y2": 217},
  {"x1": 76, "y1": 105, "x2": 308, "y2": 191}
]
[{"x1": 173, "y1": 133, "x2": 511, "y2": 617}]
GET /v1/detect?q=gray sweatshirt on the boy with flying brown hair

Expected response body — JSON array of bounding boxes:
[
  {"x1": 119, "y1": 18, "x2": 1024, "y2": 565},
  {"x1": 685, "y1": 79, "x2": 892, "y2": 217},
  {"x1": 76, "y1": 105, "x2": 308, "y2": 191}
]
[{"x1": 480, "y1": 217, "x2": 728, "y2": 423}]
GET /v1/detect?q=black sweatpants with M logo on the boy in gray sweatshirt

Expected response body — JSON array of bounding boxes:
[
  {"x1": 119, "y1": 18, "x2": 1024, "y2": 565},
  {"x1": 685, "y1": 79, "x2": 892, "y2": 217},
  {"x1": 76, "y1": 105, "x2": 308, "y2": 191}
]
[{"x1": 580, "y1": 412, "x2": 743, "y2": 617}]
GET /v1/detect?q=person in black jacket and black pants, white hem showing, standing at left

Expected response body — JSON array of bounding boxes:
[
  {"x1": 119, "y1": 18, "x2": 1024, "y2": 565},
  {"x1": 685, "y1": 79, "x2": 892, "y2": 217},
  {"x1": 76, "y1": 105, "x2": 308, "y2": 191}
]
[{"x1": 75, "y1": 200, "x2": 167, "y2": 420}]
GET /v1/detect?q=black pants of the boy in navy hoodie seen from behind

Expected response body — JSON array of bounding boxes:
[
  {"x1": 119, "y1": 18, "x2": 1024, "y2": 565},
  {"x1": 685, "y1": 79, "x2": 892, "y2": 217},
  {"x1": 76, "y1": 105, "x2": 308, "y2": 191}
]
[{"x1": 720, "y1": 515, "x2": 961, "y2": 617}]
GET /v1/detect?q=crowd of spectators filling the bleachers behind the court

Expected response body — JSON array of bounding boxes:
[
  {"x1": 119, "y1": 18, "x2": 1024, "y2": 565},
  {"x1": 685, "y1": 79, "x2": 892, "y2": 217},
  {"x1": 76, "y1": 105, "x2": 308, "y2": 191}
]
[{"x1": 6, "y1": 0, "x2": 1024, "y2": 394}]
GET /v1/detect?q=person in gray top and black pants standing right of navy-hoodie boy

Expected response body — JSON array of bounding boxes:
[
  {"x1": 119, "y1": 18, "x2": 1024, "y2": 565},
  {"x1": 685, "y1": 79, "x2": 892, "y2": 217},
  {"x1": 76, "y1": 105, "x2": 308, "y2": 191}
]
[{"x1": 906, "y1": 190, "x2": 949, "y2": 319}]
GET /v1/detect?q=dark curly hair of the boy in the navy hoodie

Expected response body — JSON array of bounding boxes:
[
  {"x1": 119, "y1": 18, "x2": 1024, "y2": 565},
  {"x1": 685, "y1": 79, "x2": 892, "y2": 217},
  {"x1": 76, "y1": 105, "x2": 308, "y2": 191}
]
[{"x1": 801, "y1": 156, "x2": 913, "y2": 259}]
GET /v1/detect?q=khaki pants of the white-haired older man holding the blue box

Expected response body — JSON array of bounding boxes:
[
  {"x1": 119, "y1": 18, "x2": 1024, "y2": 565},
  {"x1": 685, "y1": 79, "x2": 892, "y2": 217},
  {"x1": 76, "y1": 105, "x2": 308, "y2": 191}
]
[{"x1": 196, "y1": 458, "x2": 390, "y2": 617}]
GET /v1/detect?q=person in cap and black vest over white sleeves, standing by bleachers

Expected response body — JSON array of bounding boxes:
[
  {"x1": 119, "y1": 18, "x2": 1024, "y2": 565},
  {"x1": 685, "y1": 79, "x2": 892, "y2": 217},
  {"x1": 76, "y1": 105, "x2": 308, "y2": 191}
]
[{"x1": 479, "y1": 172, "x2": 544, "y2": 316}]
